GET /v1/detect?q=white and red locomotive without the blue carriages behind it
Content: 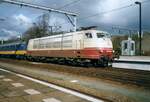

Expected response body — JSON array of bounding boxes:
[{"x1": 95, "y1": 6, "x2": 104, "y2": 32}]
[{"x1": 27, "y1": 30, "x2": 113, "y2": 66}]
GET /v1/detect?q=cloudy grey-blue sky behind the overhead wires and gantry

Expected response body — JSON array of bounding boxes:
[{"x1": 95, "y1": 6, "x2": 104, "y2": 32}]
[{"x1": 0, "y1": 0, "x2": 150, "y2": 39}]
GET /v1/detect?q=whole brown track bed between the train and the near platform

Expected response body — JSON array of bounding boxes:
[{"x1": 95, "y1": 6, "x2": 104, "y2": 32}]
[{"x1": 0, "y1": 59, "x2": 150, "y2": 102}]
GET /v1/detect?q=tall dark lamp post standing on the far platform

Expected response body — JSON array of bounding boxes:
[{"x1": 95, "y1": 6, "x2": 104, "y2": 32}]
[{"x1": 135, "y1": 1, "x2": 142, "y2": 56}]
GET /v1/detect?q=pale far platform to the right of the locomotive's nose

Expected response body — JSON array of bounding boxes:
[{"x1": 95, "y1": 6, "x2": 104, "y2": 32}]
[{"x1": 112, "y1": 56, "x2": 150, "y2": 71}]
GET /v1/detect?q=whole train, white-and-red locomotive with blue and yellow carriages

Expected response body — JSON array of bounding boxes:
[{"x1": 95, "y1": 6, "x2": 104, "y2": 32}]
[{"x1": 0, "y1": 30, "x2": 113, "y2": 66}]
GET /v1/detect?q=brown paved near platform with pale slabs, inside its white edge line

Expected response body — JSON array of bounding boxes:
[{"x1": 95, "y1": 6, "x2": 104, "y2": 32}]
[{"x1": 0, "y1": 70, "x2": 89, "y2": 102}]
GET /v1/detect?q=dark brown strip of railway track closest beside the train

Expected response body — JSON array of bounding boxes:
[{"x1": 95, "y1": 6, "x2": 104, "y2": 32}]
[{"x1": 1, "y1": 59, "x2": 150, "y2": 89}]
